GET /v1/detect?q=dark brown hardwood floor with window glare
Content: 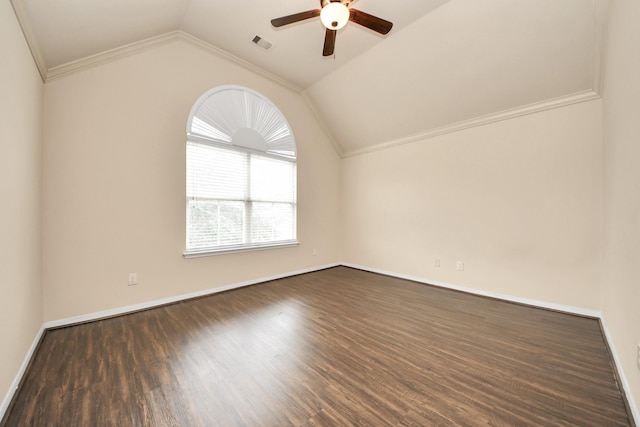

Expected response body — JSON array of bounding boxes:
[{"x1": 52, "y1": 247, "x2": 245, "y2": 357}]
[{"x1": 1, "y1": 267, "x2": 632, "y2": 427}]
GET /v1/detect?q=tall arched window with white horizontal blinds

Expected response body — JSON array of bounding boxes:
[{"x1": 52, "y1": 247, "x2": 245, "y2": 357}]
[{"x1": 185, "y1": 86, "x2": 297, "y2": 257}]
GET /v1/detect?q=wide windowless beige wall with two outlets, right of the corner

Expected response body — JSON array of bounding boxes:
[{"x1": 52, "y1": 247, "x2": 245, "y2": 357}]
[{"x1": 342, "y1": 100, "x2": 602, "y2": 310}]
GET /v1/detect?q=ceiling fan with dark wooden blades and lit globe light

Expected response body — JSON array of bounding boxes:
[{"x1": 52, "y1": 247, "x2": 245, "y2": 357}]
[{"x1": 271, "y1": 0, "x2": 393, "y2": 56}]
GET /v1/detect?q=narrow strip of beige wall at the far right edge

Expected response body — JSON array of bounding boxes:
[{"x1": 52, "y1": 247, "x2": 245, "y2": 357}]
[{"x1": 602, "y1": 0, "x2": 640, "y2": 416}]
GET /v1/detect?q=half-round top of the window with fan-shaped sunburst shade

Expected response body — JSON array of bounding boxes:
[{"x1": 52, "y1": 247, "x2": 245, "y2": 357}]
[{"x1": 187, "y1": 85, "x2": 296, "y2": 159}]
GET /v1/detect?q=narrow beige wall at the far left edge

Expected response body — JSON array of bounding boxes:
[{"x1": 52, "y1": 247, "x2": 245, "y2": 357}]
[{"x1": 0, "y1": 1, "x2": 43, "y2": 414}]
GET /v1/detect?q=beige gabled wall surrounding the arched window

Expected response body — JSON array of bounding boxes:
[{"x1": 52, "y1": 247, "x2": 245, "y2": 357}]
[{"x1": 43, "y1": 40, "x2": 340, "y2": 321}]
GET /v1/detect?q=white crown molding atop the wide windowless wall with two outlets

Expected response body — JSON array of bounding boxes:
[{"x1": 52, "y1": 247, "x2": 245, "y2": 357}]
[{"x1": 342, "y1": 90, "x2": 601, "y2": 158}]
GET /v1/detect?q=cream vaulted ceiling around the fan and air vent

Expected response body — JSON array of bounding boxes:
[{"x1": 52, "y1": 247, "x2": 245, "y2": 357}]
[{"x1": 12, "y1": 0, "x2": 606, "y2": 155}]
